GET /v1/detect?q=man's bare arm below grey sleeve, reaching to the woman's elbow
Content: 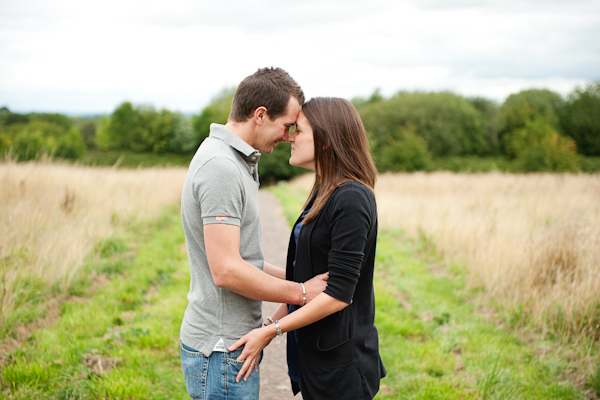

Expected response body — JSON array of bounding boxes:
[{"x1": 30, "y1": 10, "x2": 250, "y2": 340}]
[{"x1": 204, "y1": 224, "x2": 327, "y2": 304}]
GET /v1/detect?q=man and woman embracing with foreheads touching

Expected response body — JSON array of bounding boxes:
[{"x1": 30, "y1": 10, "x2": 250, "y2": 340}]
[{"x1": 180, "y1": 68, "x2": 386, "y2": 400}]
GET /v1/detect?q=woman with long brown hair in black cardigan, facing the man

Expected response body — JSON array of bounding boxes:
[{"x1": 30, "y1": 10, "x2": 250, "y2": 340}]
[{"x1": 230, "y1": 98, "x2": 386, "y2": 400}]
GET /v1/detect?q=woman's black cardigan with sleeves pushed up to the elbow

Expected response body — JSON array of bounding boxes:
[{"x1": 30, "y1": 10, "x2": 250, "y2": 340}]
[{"x1": 286, "y1": 182, "x2": 386, "y2": 400}]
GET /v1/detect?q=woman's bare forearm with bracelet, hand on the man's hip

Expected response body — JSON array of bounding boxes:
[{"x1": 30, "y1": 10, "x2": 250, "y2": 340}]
[{"x1": 229, "y1": 293, "x2": 348, "y2": 382}]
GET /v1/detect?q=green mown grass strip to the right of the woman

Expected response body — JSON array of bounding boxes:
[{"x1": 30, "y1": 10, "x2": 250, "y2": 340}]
[{"x1": 270, "y1": 184, "x2": 600, "y2": 400}]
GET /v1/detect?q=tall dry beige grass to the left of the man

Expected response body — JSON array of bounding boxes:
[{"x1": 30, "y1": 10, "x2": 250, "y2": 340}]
[{"x1": 0, "y1": 160, "x2": 186, "y2": 321}]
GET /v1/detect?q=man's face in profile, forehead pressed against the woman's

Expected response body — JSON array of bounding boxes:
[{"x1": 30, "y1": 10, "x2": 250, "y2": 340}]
[{"x1": 254, "y1": 96, "x2": 300, "y2": 154}]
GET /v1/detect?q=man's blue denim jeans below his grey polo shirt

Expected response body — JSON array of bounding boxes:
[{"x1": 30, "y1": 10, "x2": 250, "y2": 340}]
[{"x1": 181, "y1": 343, "x2": 262, "y2": 400}]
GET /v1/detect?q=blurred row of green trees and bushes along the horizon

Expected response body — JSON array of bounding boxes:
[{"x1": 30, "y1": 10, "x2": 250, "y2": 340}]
[{"x1": 0, "y1": 82, "x2": 600, "y2": 181}]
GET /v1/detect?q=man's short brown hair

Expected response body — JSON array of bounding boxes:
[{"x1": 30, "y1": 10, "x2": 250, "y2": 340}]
[{"x1": 229, "y1": 67, "x2": 304, "y2": 122}]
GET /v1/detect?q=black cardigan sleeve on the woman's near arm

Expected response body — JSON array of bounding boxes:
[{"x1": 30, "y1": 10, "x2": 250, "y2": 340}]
[{"x1": 325, "y1": 183, "x2": 375, "y2": 304}]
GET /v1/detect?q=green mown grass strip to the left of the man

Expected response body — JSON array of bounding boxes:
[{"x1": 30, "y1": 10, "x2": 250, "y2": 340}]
[{"x1": 0, "y1": 207, "x2": 189, "y2": 399}]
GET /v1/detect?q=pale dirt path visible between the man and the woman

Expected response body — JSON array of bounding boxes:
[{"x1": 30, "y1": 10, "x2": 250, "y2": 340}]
[{"x1": 258, "y1": 190, "x2": 302, "y2": 400}]
